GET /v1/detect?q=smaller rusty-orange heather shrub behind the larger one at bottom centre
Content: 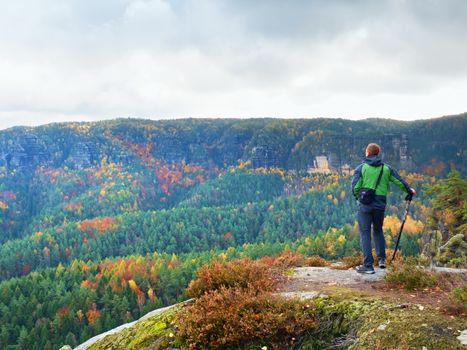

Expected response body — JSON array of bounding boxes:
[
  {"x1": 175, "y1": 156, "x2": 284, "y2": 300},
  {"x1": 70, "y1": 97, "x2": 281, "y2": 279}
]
[{"x1": 186, "y1": 258, "x2": 279, "y2": 298}]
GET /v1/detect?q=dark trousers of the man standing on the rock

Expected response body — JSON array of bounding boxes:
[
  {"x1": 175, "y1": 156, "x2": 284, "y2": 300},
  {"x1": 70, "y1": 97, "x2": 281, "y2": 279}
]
[{"x1": 358, "y1": 208, "x2": 386, "y2": 267}]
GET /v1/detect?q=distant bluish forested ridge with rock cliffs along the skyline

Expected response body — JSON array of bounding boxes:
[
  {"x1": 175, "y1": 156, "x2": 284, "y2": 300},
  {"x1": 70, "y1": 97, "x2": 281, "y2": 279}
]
[{"x1": 0, "y1": 114, "x2": 467, "y2": 171}]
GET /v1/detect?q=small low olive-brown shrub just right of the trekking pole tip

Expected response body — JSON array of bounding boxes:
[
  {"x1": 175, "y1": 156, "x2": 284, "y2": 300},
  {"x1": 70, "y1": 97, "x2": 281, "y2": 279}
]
[{"x1": 384, "y1": 257, "x2": 436, "y2": 290}]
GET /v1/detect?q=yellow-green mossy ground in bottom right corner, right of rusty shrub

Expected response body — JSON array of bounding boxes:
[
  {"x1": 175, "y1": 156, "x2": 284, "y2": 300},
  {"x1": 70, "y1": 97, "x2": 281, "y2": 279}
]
[{"x1": 298, "y1": 298, "x2": 467, "y2": 350}]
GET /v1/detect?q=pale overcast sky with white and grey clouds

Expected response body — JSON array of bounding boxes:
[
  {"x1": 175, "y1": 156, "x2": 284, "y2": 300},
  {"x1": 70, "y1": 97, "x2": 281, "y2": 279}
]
[{"x1": 0, "y1": 0, "x2": 467, "y2": 129}]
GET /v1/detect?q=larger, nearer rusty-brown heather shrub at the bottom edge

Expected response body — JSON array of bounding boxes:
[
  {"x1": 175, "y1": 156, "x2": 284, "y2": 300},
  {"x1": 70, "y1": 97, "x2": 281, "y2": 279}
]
[{"x1": 176, "y1": 287, "x2": 316, "y2": 348}]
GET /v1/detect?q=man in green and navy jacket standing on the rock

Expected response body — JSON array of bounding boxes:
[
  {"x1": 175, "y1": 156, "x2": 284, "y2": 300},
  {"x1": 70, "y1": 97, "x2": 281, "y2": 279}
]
[{"x1": 352, "y1": 143, "x2": 416, "y2": 274}]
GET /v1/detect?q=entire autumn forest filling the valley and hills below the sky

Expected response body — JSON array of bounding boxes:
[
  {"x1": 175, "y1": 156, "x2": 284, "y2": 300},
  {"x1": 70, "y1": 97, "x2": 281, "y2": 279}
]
[{"x1": 0, "y1": 115, "x2": 467, "y2": 349}]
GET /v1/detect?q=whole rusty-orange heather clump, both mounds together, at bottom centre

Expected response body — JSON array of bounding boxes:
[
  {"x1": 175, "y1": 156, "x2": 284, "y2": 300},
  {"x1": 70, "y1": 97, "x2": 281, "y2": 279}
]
[{"x1": 177, "y1": 253, "x2": 316, "y2": 348}]
